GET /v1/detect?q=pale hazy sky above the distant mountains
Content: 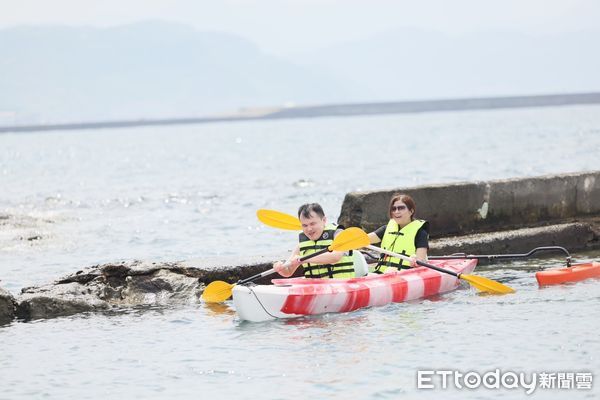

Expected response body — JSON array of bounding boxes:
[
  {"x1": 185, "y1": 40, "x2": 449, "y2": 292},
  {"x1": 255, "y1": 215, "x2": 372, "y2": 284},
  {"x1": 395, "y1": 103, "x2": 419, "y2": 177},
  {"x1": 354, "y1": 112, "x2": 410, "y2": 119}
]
[{"x1": 0, "y1": 0, "x2": 600, "y2": 54}]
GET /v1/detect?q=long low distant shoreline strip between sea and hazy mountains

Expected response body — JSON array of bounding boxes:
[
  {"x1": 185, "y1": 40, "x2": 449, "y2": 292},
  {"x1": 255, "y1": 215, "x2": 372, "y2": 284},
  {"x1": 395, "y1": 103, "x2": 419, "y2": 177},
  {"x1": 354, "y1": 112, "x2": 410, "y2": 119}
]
[{"x1": 0, "y1": 92, "x2": 600, "y2": 133}]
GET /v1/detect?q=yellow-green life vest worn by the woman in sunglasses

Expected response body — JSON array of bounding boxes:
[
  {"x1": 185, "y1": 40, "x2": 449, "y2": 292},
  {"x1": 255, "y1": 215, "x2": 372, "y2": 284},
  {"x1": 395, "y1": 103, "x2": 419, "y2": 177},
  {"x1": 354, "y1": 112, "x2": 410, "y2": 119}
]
[{"x1": 374, "y1": 219, "x2": 427, "y2": 274}]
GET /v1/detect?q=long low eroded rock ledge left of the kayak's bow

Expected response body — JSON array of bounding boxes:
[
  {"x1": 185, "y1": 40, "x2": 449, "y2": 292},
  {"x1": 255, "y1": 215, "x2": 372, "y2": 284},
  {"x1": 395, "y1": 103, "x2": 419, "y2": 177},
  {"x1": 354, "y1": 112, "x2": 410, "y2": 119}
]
[{"x1": 16, "y1": 259, "x2": 271, "y2": 320}]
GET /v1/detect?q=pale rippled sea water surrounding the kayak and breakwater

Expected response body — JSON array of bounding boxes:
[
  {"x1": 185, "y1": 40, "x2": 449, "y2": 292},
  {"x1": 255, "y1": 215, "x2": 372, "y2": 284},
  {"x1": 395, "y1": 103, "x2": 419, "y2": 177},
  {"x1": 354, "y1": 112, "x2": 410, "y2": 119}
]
[{"x1": 0, "y1": 106, "x2": 600, "y2": 399}]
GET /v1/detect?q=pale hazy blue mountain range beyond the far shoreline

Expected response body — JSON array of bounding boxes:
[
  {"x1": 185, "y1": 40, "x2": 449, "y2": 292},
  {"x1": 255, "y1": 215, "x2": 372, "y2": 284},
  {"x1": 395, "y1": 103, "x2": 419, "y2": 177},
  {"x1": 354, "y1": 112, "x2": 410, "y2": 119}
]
[{"x1": 0, "y1": 21, "x2": 600, "y2": 125}]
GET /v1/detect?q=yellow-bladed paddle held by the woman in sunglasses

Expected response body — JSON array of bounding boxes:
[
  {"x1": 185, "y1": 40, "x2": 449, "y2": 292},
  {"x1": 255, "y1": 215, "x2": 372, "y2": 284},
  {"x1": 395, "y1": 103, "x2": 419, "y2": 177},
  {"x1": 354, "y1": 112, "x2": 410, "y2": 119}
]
[{"x1": 256, "y1": 210, "x2": 515, "y2": 294}]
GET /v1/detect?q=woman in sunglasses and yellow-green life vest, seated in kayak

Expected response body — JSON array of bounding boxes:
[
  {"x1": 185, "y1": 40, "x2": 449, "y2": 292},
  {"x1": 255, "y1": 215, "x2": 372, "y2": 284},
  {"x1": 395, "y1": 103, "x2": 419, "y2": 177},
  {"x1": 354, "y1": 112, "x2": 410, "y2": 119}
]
[{"x1": 369, "y1": 194, "x2": 429, "y2": 274}]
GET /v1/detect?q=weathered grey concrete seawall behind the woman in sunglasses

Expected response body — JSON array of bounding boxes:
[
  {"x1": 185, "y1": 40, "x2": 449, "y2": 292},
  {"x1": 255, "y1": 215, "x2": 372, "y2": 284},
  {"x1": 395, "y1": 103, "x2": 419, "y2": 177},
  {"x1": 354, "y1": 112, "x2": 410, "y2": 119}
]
[{"x1": 338, "y1": 171, "x2": 600, "y2": 252}]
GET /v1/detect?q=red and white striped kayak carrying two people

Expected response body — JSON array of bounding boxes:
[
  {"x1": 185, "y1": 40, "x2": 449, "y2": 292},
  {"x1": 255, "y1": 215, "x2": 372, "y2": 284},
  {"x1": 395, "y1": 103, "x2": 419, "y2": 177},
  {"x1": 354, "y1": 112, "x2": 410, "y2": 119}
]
[{"x1": 233, "y1": 259, "x2": 477, "y2": 322}]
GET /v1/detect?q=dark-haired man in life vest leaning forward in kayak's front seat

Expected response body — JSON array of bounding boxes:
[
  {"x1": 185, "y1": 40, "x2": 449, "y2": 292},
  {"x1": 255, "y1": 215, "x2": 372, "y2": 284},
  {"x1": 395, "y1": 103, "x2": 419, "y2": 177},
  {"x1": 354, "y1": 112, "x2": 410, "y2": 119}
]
[{"x1": 273, "y1": 203, "x2": 354, "y2": 278}]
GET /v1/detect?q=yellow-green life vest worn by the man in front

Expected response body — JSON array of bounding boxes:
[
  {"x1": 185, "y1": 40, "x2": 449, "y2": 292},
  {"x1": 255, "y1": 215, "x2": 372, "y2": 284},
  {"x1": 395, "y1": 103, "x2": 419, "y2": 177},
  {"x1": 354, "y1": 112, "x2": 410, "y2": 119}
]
[{"x1": 299, "y1": 224, "x2": 354, "y2": 278}]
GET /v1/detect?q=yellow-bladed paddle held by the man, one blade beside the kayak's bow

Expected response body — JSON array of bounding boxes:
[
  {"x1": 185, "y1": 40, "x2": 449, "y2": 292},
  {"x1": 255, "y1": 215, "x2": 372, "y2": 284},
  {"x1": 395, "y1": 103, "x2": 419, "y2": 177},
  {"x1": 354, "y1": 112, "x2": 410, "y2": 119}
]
[{"x1": 202, "y1": 227, "x2": 369, "y2": 303}]
